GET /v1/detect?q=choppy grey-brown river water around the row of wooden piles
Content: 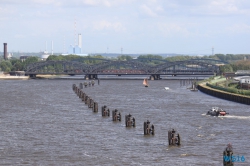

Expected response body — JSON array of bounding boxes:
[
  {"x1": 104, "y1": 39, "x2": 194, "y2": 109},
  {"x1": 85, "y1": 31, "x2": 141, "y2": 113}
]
[{"x1": 0, "y1": 80, "x2": 250, "y2": 166}]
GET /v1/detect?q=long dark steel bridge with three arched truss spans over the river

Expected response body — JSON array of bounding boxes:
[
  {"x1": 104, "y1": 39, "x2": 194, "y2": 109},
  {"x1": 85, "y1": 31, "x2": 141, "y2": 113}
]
[{"x1": 25, "y1": 58, "x2": 225, "y2": 80}]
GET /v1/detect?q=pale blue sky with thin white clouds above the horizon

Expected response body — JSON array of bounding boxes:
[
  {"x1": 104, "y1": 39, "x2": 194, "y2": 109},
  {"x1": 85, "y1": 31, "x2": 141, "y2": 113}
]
[{"x1": 0, "y1": 0, "x2": 250, "y2": 55}]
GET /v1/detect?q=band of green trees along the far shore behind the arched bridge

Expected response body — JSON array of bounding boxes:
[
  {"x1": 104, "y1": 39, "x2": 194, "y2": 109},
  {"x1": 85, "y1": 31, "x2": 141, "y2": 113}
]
[{"x1": 0, "y1": 54, "x2": 250, "y2": 72}]
